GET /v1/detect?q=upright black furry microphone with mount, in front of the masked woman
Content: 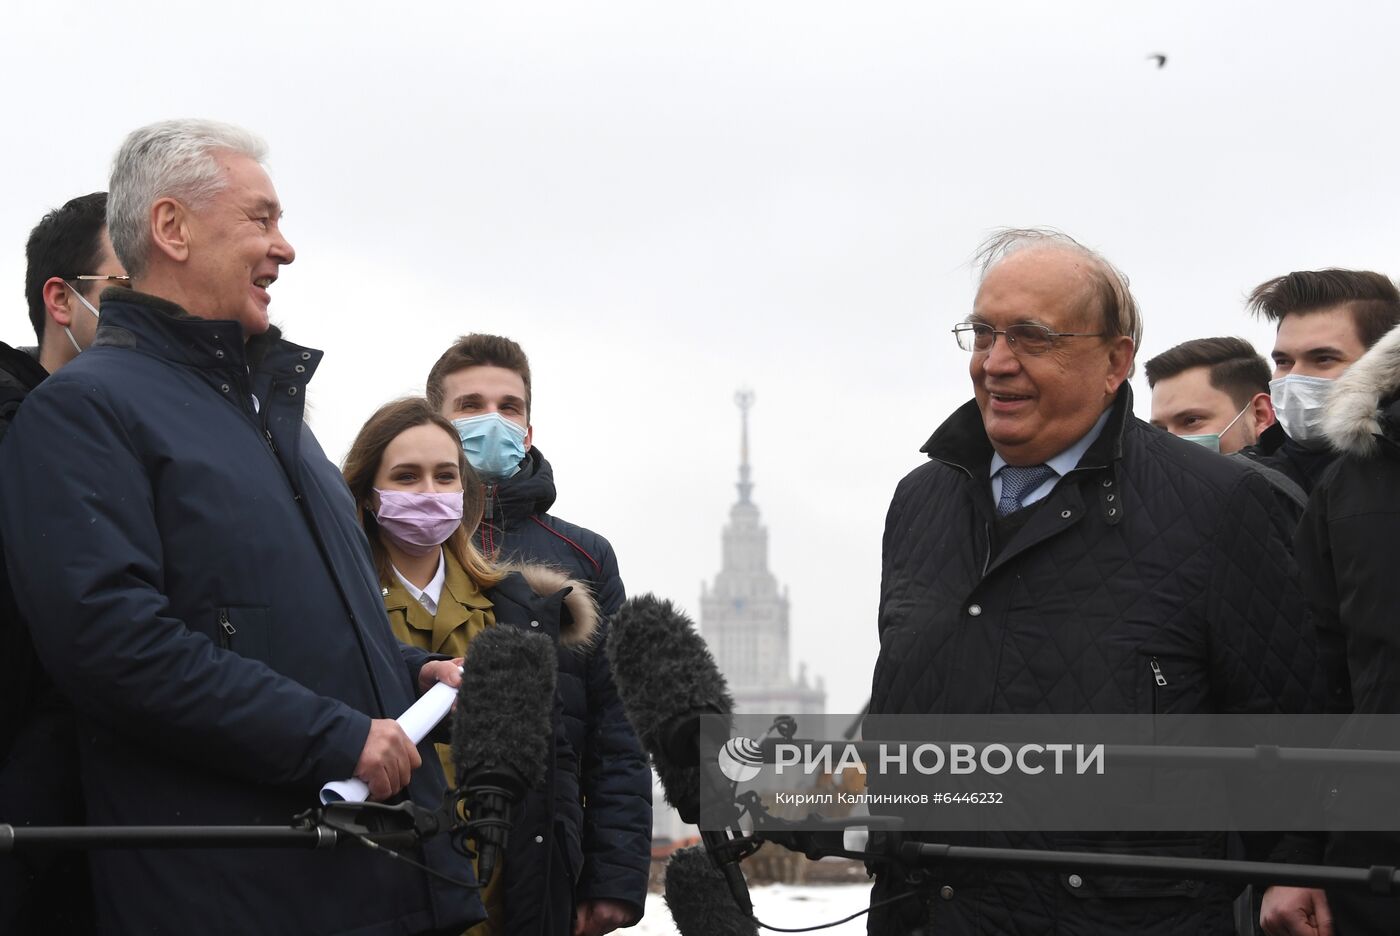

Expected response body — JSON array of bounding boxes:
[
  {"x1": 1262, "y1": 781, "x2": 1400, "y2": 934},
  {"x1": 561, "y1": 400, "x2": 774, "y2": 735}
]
[{"x1": 452, "y1": 624, "x2": 559, "y2": 887}]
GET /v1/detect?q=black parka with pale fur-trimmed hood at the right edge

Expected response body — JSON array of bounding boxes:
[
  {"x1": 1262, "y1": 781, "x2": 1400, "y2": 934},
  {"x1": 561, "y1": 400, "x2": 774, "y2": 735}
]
[{"x1": 1285, "y1": 321, "x2": 1400, "y2": 933}]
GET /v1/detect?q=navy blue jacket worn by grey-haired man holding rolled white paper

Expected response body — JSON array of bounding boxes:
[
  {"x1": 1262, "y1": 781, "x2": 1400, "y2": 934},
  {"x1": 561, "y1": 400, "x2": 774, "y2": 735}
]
[{"x1": 0, "y1": 292, "x2": 483, "y2": 936}]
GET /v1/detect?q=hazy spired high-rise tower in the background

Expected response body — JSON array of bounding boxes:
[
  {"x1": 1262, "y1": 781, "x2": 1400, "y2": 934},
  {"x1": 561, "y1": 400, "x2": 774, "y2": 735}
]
[{"x1": 700, "y1": 390, "x2": 826, "y2": 715}]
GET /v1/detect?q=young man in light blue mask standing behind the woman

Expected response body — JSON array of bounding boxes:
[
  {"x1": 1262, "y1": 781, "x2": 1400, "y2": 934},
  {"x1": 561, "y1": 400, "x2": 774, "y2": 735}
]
[{"x1": 426, "y1": 334, "x2": 651, "y2": 936}]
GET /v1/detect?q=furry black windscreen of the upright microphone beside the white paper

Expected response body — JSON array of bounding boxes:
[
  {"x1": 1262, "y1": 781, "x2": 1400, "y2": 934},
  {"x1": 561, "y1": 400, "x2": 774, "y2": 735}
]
[{"x1": 452, "y1": 624, "x2": 559, "y2": 789}]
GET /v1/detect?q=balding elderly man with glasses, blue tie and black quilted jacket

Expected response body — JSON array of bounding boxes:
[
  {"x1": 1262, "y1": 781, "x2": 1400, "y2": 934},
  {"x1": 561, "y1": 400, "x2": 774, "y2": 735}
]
[{"x1": 869, "y1": 231, "x2": 1320, "y2": 936}]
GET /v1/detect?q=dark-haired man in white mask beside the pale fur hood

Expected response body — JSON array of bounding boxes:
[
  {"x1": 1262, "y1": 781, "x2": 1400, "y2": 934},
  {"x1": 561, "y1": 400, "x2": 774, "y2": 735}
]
[{"x1": 1247, "y1": 269, "x2": 1400, "y2": 492}]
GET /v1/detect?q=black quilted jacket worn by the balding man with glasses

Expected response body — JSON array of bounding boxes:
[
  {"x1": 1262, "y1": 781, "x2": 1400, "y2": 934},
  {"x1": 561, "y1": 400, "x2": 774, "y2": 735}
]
[{"x1": 869, "y1": 383, "x2": 1320, "y2": 936}]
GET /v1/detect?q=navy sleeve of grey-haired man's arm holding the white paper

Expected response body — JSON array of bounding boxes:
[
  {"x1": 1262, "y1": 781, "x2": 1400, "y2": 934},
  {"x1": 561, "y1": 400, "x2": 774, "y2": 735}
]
[{"x1": 0, "y1": 382, "x2": 370, "y2": 783}]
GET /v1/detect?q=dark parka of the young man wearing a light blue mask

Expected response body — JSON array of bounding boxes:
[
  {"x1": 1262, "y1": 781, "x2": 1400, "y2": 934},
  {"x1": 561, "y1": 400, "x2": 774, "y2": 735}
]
[{"x1": 477, "y1": 446, "x2": 651, "y2": 918}]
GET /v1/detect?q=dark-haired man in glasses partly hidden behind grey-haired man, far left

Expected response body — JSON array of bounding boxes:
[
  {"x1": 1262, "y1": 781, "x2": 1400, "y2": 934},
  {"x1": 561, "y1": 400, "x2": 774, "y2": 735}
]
[{"x1": 0, "y1": 192, "x2": 126, "y2": 933}]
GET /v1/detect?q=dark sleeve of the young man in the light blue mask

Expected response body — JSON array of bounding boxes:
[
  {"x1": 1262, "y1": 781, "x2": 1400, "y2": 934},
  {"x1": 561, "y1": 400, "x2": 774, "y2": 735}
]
[{"x1": 578, "y1": 621, "x2": 651, "y2": 918}]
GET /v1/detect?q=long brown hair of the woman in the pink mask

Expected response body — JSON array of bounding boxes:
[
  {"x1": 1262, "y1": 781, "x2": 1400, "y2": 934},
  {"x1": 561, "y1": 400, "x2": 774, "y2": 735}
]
[{"x1": 340, "y1": 396, "x2": 505, "y2": 588}]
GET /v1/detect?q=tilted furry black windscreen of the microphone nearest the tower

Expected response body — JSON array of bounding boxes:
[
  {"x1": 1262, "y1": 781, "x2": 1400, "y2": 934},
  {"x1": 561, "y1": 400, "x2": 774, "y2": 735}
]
[{"x1": 608, "y1": 593, "x2": 734, "y2": 807}]
